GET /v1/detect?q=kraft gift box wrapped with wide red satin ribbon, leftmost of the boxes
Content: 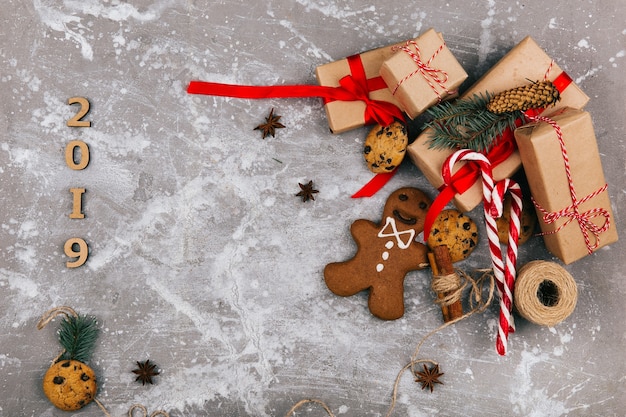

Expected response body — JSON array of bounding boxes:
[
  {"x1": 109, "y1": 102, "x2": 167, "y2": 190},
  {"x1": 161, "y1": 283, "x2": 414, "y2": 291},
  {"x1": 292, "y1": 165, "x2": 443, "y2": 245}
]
[{"x1": 315, "y1": 42, "x2": 405, "y2": 133}]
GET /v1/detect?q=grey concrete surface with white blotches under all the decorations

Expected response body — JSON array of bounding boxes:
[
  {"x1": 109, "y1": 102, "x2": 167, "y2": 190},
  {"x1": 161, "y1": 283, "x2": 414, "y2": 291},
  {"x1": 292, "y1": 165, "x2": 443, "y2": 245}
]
[{"x1": 0, "y1": 0, "x2": 626, "y2": 417}]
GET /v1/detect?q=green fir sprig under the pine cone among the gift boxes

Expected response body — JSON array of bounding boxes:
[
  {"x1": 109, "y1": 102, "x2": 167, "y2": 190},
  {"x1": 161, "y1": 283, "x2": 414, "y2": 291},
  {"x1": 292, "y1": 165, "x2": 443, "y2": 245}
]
[{"x1": 424, "y1": 93, "x2": 522, "y2": 152}]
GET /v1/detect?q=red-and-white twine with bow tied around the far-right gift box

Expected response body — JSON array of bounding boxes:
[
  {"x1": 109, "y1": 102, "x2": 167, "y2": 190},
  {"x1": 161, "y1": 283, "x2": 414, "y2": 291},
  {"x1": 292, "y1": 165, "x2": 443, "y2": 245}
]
[{"x1": 529, "y1": 116, "x2": 611, "y2": 254}]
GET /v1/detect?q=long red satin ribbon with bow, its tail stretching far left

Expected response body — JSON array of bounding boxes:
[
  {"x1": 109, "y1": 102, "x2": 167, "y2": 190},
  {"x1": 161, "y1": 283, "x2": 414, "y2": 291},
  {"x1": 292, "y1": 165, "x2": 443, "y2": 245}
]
[{"x1": 187, "y1": 55, "x2": 404, "y2": 126}]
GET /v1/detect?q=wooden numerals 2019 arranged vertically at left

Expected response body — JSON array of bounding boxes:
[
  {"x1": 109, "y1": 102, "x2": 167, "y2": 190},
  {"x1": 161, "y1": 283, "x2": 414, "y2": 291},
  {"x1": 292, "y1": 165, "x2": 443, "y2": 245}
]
[{"x1": 63, "y1": 97, "x2": 91, "y2": 268}]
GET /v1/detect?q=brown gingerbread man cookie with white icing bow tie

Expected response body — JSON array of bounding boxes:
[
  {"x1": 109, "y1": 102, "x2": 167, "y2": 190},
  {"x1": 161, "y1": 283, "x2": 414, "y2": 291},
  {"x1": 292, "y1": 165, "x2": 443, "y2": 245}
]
[{"x1": 324, "y1": 187, "x2": 431, "y2": 320}]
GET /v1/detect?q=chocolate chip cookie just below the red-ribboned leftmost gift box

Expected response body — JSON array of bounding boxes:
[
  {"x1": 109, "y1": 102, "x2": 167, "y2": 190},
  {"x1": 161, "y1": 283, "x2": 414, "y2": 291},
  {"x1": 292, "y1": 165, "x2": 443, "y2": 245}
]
[{"x1": 363, "y1": 121, "x2": 409, "y2": 173}]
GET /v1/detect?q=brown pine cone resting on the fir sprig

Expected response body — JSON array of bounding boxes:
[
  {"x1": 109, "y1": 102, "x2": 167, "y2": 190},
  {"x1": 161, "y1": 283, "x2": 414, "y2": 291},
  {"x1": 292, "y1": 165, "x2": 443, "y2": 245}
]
[{"x1": 487, "y1": 81, "x2": 560, "y2": 114}]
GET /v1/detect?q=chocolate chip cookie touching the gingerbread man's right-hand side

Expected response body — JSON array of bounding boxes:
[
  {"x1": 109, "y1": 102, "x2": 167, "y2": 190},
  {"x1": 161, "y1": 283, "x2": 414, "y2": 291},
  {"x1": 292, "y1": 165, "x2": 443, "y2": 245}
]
[{"x1": 426, "y1": 209, "x2": 478, "y2": 263}]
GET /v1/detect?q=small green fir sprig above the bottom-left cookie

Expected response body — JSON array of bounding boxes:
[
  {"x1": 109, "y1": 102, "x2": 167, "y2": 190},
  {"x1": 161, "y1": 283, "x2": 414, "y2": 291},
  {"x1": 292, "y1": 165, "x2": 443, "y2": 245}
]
[{"x1": 59, "y1": 316, "x2": 98, "y2": 362}]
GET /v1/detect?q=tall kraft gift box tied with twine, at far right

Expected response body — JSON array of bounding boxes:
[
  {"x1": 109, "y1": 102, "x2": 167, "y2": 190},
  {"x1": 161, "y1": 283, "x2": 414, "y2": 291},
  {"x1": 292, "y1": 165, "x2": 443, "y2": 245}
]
[{"x1": 515, "y1": 109, "x2": 618, "y2": 264}]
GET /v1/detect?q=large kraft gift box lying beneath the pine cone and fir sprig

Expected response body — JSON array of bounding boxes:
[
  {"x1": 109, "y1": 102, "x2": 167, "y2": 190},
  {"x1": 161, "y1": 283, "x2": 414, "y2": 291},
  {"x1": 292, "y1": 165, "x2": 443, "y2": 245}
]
[{"x1": 407, "y1": 36, "x2": 589, "y2": 211}]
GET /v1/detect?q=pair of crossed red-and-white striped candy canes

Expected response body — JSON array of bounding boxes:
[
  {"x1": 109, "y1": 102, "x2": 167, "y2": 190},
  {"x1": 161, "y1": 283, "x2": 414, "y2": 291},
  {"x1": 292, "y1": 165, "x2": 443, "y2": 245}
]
[{"x1": 443, "y1": 149, "x2": 522, "y2": 355}]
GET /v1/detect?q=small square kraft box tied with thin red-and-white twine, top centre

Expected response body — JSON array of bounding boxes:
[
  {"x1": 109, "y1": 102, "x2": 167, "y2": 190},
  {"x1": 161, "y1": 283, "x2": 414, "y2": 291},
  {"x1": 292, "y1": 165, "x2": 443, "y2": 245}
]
[{"x1": 380, "y1": 29, "x2": 467, "y2": 119}]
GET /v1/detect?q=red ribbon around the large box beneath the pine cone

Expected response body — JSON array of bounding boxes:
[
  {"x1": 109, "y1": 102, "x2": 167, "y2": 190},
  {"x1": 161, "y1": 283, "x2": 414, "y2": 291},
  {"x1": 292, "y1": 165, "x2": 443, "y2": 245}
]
[{"x1": 424, "y1": 71, "x2": 572, "y2": 241}]
